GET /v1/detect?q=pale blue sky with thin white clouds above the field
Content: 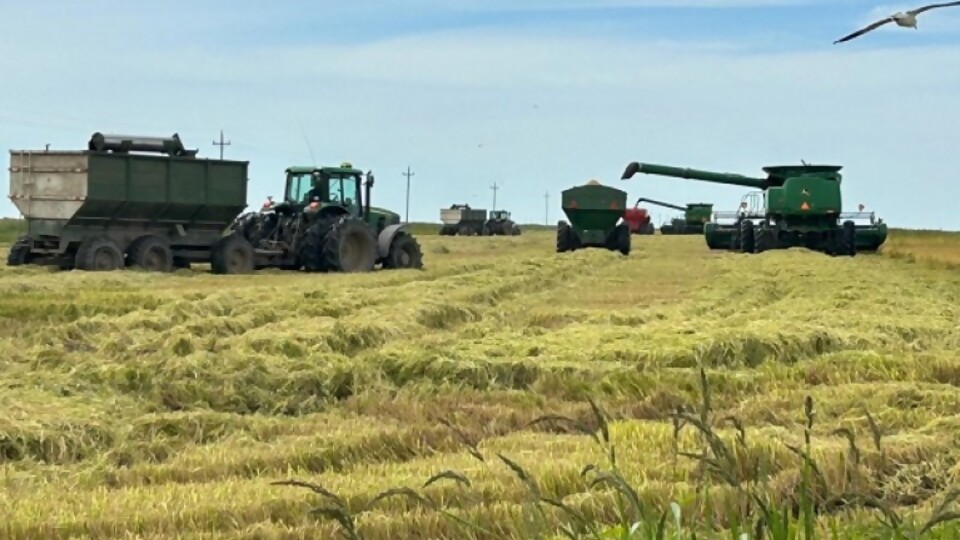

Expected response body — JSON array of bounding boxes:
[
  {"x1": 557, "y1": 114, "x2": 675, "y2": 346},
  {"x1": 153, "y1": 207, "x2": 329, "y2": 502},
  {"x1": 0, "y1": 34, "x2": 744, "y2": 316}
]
[{"x1": 0, "y1": 0, "x2": 960, "y2": 230}]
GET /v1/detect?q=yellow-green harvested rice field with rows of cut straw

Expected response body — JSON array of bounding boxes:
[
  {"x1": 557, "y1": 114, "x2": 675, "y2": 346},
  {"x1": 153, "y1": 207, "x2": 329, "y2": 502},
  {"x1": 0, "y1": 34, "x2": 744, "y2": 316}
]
[{"x1": 0, "y1": 231, "x2": 960, "y2": 540}]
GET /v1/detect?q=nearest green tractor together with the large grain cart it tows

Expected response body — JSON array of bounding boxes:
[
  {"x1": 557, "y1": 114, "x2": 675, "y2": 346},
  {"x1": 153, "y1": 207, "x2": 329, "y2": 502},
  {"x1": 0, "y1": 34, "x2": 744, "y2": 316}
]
[{"x1": 7, "y1": 133, "x2": 422, "y2": 274}]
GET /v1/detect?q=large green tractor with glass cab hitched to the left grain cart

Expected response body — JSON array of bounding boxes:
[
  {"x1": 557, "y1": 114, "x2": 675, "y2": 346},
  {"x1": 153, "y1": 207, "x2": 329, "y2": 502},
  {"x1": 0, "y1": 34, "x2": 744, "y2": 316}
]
[{"x1": 232, "y1": 163, "x2": 423, "y2": 272}]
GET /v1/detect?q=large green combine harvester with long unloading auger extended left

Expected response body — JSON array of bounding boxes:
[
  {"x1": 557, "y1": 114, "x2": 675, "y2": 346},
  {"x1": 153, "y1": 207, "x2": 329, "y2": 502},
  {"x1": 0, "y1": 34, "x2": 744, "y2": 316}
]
[{"x1": 622, "y1": 162, "x2": 887, "y2": 257}]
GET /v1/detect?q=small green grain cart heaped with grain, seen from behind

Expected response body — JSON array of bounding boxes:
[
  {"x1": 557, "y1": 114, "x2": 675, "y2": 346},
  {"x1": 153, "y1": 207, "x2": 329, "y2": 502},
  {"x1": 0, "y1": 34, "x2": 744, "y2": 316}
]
[{"x1": 557, "y1": 180, "x2": 630, "y2": 255}]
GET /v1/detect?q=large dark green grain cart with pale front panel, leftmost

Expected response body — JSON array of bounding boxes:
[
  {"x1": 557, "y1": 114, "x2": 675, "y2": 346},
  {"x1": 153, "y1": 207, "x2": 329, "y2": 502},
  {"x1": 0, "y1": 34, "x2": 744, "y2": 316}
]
[{"x1": 7, "y1": 133, "x2": 253, "y2": 273}]
